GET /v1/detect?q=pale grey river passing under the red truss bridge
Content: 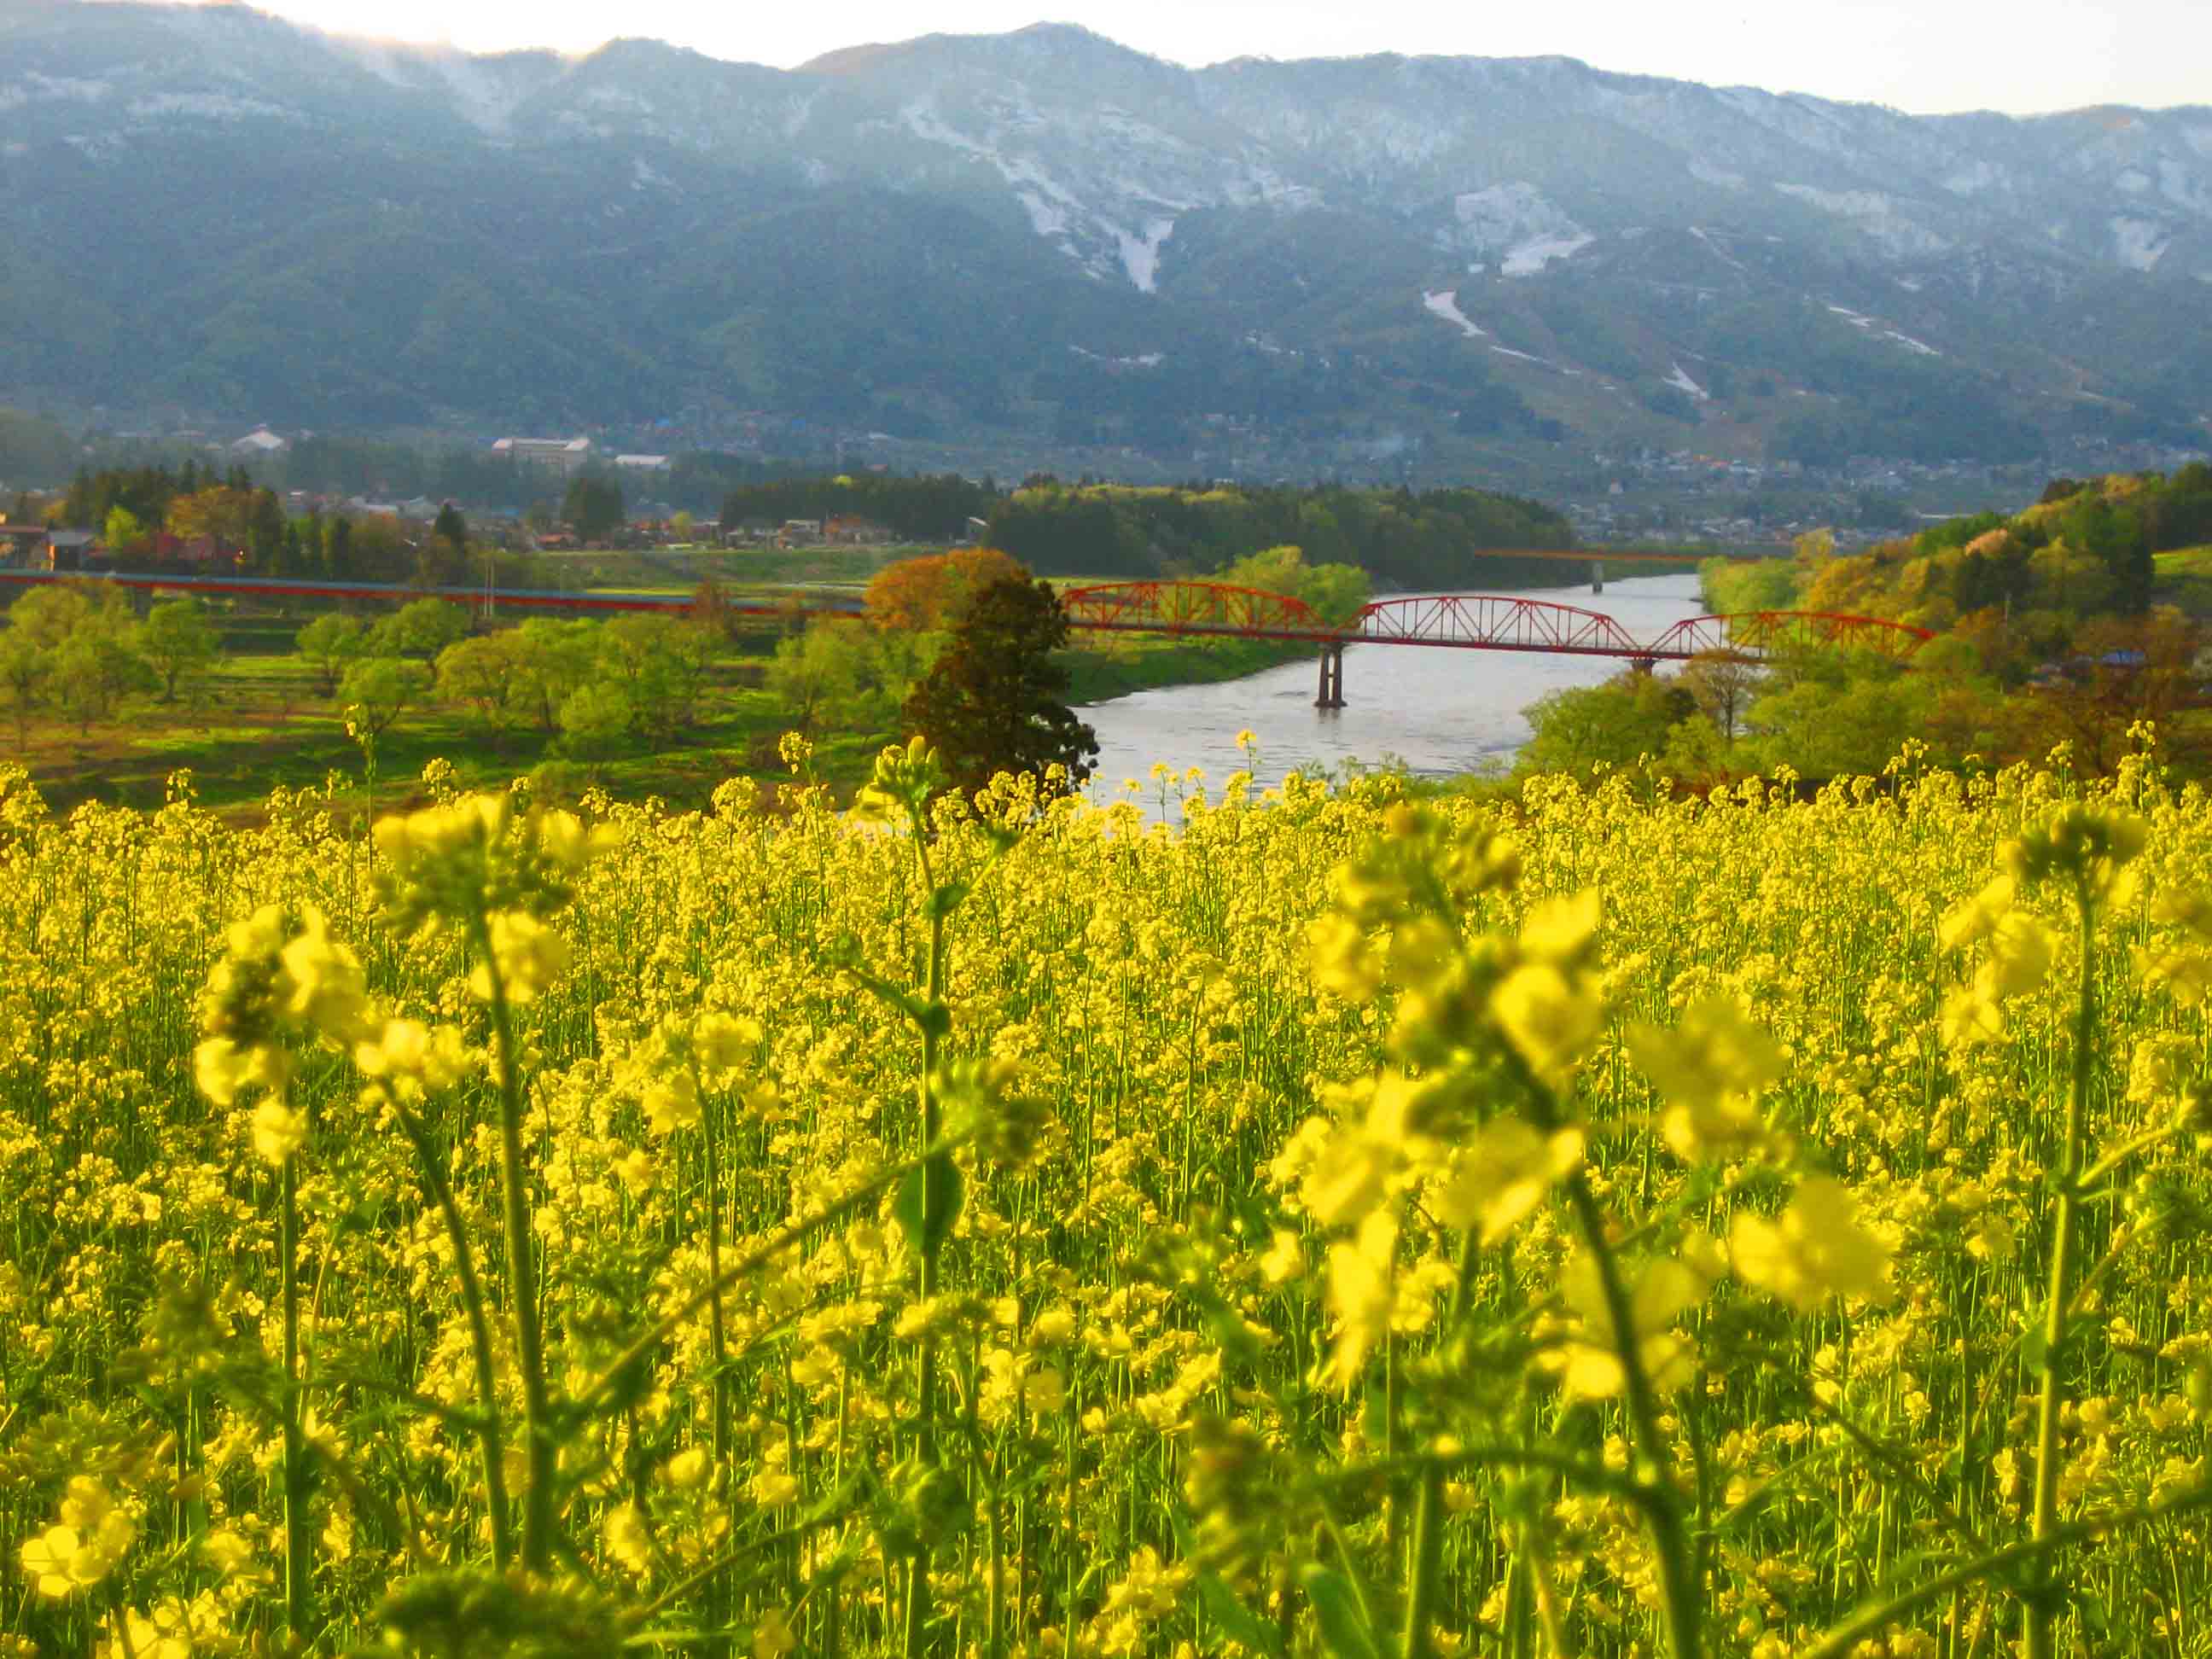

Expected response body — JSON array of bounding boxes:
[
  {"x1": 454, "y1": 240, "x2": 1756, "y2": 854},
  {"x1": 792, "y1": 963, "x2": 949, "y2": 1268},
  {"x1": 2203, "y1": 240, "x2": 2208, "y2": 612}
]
[{"x1": 1075, "y1": 573, "x2": 1703, "y2": 810}]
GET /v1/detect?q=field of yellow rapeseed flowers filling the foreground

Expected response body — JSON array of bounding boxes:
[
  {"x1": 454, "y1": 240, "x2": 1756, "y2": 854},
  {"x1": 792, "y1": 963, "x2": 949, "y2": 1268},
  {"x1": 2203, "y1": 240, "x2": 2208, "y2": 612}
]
[{"x1": 0, "y1": 732, "x2": 2212, "y2": 1659}]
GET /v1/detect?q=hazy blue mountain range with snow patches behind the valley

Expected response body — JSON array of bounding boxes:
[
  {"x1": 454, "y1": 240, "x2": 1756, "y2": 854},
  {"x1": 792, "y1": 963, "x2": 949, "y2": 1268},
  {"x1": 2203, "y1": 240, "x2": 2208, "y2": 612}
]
[{"x1": 0, "y1": 0, "x2": 2212, "y2": 469}]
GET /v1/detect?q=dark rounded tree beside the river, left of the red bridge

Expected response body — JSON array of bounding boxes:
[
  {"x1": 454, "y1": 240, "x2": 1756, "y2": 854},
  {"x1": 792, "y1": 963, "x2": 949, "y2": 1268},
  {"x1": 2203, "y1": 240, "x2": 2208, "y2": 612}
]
[{"x1": 905, "y1": 575, "x2": 1099, "y2": 795}]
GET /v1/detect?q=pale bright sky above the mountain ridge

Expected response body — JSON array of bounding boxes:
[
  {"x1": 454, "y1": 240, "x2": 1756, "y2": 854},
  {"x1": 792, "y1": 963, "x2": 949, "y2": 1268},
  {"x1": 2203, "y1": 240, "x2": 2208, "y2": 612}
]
[{"x1": 203, "y1": 0, "x2": 2212, "y2": 113}]
